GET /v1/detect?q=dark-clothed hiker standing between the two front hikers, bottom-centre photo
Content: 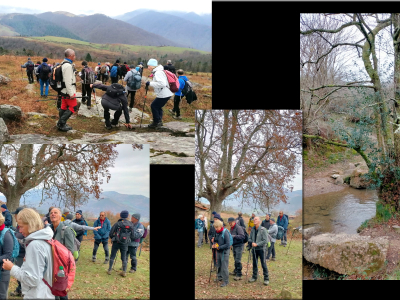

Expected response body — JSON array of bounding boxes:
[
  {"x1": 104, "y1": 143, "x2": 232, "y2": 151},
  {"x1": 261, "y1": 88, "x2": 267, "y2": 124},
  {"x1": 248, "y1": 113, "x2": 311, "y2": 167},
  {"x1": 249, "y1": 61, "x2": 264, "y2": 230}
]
[{"x1": 228, "y1": 218, "x2": 245, "y2": 280}]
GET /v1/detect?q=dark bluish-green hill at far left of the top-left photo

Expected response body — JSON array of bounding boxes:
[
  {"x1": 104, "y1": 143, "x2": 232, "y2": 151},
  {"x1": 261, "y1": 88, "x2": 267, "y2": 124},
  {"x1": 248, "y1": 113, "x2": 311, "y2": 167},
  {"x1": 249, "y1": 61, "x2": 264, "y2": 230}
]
[{"x1": 0, "y1": 14, "x2": 84, "y2": 41}]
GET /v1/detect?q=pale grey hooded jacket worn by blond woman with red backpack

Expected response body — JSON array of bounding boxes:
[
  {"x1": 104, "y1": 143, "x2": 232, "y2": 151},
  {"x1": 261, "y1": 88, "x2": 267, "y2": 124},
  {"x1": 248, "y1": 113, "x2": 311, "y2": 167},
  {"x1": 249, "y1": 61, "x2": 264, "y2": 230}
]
[{"x1": 11, "y1": 227, "x2": 55, "y2": 299}]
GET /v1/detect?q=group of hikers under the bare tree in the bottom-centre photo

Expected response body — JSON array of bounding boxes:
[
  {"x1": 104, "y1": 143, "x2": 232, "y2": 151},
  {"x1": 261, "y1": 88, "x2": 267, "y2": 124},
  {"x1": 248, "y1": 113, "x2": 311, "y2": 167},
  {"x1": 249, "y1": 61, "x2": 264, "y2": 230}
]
[{"x1": 195, "y1": 211, "x2": 289, "y2": 287}]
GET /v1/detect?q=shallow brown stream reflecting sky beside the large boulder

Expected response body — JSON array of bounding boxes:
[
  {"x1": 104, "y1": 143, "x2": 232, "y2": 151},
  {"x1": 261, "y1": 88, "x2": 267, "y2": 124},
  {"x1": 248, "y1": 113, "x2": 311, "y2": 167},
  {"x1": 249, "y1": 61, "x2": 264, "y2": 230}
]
[{"x1": 303, "y1": 187, "x2": 378, "y2": 234}]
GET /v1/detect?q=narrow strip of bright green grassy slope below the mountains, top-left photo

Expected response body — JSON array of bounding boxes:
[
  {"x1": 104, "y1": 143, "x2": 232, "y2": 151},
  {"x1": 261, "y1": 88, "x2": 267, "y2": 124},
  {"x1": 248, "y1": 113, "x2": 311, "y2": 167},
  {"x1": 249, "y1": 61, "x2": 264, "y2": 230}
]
[{"x1": 26, "y1": 36, "x2": 211, "y2": 54}]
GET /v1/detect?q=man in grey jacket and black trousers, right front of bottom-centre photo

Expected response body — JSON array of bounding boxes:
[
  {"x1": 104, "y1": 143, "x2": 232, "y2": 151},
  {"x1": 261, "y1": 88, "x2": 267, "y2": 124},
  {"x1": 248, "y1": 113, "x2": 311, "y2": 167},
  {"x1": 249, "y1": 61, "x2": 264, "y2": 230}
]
[{"x1": 248, "y1": 217, "x2": 269, "y2": 285}]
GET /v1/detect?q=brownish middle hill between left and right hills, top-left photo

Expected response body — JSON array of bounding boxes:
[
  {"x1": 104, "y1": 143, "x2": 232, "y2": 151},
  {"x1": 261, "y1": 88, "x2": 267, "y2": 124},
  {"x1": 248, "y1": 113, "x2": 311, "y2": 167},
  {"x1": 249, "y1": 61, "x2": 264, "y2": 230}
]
[{"x1": 37, "y1": 12, "x2": 183, "y2": 47}]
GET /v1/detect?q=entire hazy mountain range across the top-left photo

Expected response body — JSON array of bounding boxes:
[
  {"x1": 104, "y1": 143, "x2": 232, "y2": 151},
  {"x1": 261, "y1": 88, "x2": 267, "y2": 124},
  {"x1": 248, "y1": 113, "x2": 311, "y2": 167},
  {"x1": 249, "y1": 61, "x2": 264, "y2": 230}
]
[{"x1": 0, "y1": 9, "x2": 211, "y2": 51}]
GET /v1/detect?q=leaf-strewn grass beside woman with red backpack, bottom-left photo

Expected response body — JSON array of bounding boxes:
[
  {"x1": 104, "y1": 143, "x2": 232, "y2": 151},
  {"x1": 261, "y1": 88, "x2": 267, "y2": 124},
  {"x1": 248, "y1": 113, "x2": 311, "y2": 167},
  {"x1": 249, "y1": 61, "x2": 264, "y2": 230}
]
[{"x1": 9, "y1": 230, "x2": 150, "y2": 299}]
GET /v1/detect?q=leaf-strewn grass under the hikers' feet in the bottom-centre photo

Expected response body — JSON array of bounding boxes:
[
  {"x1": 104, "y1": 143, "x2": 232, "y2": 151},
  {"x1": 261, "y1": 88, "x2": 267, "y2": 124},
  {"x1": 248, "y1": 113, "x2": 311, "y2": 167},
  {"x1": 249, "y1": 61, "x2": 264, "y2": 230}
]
[{"x1": 195, "y1": 238, "x2": 303, "y2": 299}]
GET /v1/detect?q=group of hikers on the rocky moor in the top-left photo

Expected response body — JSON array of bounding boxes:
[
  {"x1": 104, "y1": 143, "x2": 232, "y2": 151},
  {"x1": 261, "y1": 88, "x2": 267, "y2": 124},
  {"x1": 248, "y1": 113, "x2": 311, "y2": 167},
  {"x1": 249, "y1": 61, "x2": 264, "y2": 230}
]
[{"x1": 21, "y1": 49, "x2": 197, "y2": 131}]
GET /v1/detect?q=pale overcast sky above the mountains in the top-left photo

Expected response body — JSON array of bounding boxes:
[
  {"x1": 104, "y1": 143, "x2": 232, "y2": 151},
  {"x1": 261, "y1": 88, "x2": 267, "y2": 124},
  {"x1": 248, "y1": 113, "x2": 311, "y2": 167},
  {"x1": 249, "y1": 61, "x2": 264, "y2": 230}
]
[{"x1": 0, "y1": 0, "x2": 211, "y2": 17}]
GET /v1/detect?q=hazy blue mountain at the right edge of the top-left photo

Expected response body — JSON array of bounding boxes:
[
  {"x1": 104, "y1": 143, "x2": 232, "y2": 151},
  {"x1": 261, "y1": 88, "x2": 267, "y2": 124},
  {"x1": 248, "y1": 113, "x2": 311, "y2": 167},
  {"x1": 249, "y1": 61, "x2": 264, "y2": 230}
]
[{"x1": 126, "y1": 11, "x2": 211, "y2": 51}]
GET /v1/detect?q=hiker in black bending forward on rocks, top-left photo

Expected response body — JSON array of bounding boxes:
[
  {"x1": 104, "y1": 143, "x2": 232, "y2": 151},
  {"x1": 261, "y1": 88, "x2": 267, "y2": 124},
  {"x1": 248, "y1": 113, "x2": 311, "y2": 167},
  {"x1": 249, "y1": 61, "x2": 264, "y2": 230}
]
[{"x1": 90, "y1": 83, "x2": 132, "y2": 129}]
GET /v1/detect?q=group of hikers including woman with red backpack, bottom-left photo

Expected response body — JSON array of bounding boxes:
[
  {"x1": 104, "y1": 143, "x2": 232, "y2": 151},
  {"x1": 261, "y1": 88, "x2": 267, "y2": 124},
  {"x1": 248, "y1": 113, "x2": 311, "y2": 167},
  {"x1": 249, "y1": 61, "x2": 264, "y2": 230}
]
[{"x1": 0, "y1": 204, "x2": 150, "y2": 299}]
